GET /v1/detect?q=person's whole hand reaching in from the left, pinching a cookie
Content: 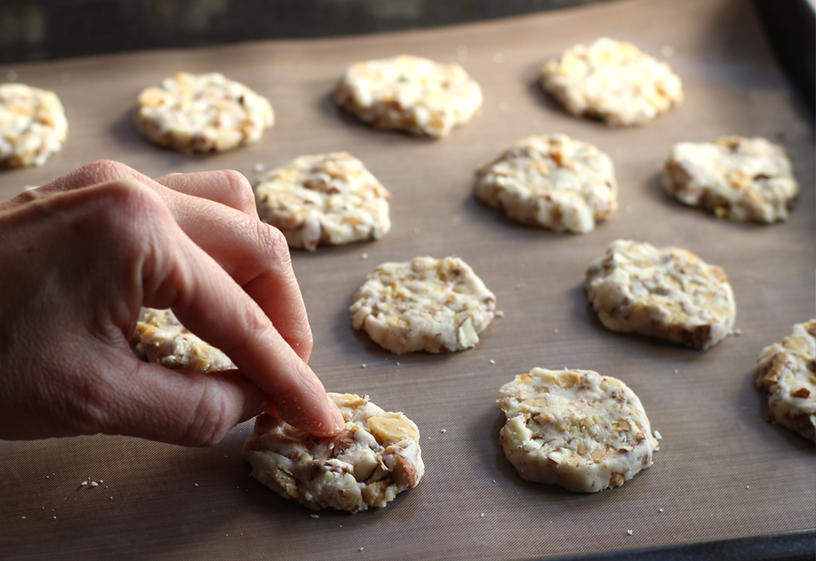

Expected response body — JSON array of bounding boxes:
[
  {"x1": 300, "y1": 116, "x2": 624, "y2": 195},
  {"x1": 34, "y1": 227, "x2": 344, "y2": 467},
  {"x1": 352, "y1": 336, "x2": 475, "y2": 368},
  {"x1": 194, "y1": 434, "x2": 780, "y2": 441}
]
[{"x1": 0, "y1": 161, "x2": 343, "y2": 446}]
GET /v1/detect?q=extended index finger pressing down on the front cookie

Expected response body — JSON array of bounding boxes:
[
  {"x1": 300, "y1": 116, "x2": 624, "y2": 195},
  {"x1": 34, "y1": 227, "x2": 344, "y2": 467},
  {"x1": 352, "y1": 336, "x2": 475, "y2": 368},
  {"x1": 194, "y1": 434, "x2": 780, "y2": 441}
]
[{"x1": 131, "y1": 182, "x2": 342, "y2": 436}]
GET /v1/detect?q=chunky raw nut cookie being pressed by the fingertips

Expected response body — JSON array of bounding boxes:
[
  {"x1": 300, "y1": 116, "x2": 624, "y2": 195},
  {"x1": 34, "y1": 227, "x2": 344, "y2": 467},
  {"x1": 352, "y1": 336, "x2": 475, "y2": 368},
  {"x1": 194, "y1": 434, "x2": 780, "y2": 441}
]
[{"x1": 244, "y1": 393, "x2": 425, "y2": 513}]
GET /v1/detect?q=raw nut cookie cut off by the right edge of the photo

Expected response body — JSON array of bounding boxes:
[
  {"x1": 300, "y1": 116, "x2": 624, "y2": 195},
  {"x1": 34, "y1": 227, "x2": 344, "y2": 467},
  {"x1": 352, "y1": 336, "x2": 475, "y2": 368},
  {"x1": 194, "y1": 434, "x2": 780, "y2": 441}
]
[{"x1": 756, "y1": 319, "x2": 816, "y2": 442}]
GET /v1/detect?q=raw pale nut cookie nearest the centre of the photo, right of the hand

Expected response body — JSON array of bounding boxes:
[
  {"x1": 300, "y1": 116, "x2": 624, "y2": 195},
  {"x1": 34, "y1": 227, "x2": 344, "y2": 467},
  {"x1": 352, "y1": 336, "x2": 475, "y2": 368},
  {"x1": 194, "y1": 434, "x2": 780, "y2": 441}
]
[{"x1": 351, "y1": 257, "x2": 496, "y2": 354}]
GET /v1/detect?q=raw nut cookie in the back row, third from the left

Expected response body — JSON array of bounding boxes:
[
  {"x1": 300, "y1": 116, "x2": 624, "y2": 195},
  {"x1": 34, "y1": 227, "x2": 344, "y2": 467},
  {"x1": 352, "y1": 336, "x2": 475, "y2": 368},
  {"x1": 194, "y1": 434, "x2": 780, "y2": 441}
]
[{"x1": 334, "y1": 55, "x2": 482, "y2": 138}]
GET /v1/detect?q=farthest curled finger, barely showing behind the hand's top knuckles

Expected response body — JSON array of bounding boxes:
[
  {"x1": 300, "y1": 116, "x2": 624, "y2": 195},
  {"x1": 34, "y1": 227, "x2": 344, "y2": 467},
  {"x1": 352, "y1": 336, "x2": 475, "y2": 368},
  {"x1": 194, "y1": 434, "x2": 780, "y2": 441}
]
[{"x1": 151, "y1": 170, "x2": 258, "y2": 218}]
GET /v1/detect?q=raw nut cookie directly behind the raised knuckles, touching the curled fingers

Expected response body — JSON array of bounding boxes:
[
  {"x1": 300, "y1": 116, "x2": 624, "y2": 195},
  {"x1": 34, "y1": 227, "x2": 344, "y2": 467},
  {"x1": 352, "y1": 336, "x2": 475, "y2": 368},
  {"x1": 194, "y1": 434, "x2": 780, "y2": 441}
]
[{"x1": 255, "y1": 152, "x2": 391, "y2": 250}]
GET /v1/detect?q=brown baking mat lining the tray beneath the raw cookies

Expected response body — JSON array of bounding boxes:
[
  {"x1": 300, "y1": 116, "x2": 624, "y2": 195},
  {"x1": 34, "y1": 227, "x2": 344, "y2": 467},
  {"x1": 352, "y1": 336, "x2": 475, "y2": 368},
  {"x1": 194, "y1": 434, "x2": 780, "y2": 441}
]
[{"x1": 0, "y1": 0, "x2": 816, "y2": 560}]
